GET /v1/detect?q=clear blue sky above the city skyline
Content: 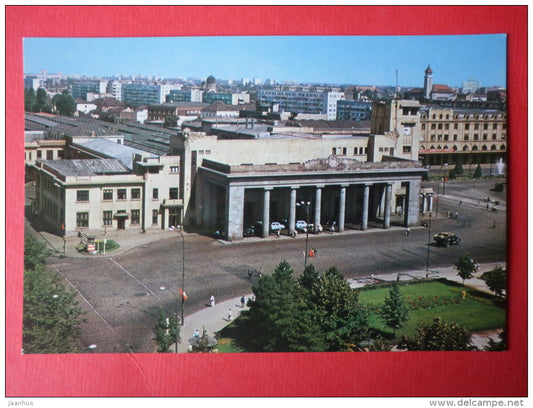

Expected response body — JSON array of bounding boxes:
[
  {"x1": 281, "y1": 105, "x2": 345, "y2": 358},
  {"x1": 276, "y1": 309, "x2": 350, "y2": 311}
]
[{"x1": 24, "y1": 34, "x2": 506, "y2": 87}]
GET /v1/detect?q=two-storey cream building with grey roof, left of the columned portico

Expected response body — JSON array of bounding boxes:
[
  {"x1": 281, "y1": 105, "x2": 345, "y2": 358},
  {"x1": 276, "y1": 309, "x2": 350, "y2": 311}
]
[{"x1": 32, "y1": 155, "x2": 183, "y2": 235}]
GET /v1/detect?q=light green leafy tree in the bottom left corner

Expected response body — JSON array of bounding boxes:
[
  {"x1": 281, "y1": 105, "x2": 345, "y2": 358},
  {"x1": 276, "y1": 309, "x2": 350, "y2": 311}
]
[{"x1": 22, "y1": 237, "x2": 83, "y2": 353}]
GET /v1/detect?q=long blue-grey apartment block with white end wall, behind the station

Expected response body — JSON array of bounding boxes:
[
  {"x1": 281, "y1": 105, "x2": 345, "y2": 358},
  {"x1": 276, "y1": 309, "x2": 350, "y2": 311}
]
[{"x1": 257, "y1": 89, "x2": 344, "y2": 120}]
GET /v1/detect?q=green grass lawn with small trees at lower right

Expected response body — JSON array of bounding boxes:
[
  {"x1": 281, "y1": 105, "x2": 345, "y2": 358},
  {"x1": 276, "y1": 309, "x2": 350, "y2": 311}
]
[{"x1": 359, "y1": 280, "x2": 505, "y2": 338}]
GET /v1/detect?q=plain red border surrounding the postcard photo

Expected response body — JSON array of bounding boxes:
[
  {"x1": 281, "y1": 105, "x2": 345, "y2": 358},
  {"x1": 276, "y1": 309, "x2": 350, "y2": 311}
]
[{"x1": 5, "y1": 6, "x2": 527, "y2": 397}]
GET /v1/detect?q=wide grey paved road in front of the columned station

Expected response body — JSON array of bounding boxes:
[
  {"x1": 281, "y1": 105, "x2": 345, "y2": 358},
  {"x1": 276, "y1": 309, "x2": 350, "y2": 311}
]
[{"x1": 49, "y1": 183, "x2": 507, "y2": 352}]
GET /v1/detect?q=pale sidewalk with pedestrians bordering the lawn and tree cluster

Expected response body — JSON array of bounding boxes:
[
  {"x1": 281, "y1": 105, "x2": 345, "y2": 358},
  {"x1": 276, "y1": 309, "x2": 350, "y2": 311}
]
[{"x1": 172, "y1": 262, "x2": 505, "y2": 353}]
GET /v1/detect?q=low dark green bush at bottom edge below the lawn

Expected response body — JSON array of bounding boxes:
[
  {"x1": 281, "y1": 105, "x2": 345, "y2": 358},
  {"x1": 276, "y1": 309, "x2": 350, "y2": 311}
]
[{"x1": 398, "y1": 318, "x2": 475, "y2": 351}]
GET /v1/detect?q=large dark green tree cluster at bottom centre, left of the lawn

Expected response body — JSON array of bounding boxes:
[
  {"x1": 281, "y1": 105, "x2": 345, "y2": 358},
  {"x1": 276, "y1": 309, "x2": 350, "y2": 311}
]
[{"x1": 244, "y1": 261, "x2": 368, "y2": 351}]
